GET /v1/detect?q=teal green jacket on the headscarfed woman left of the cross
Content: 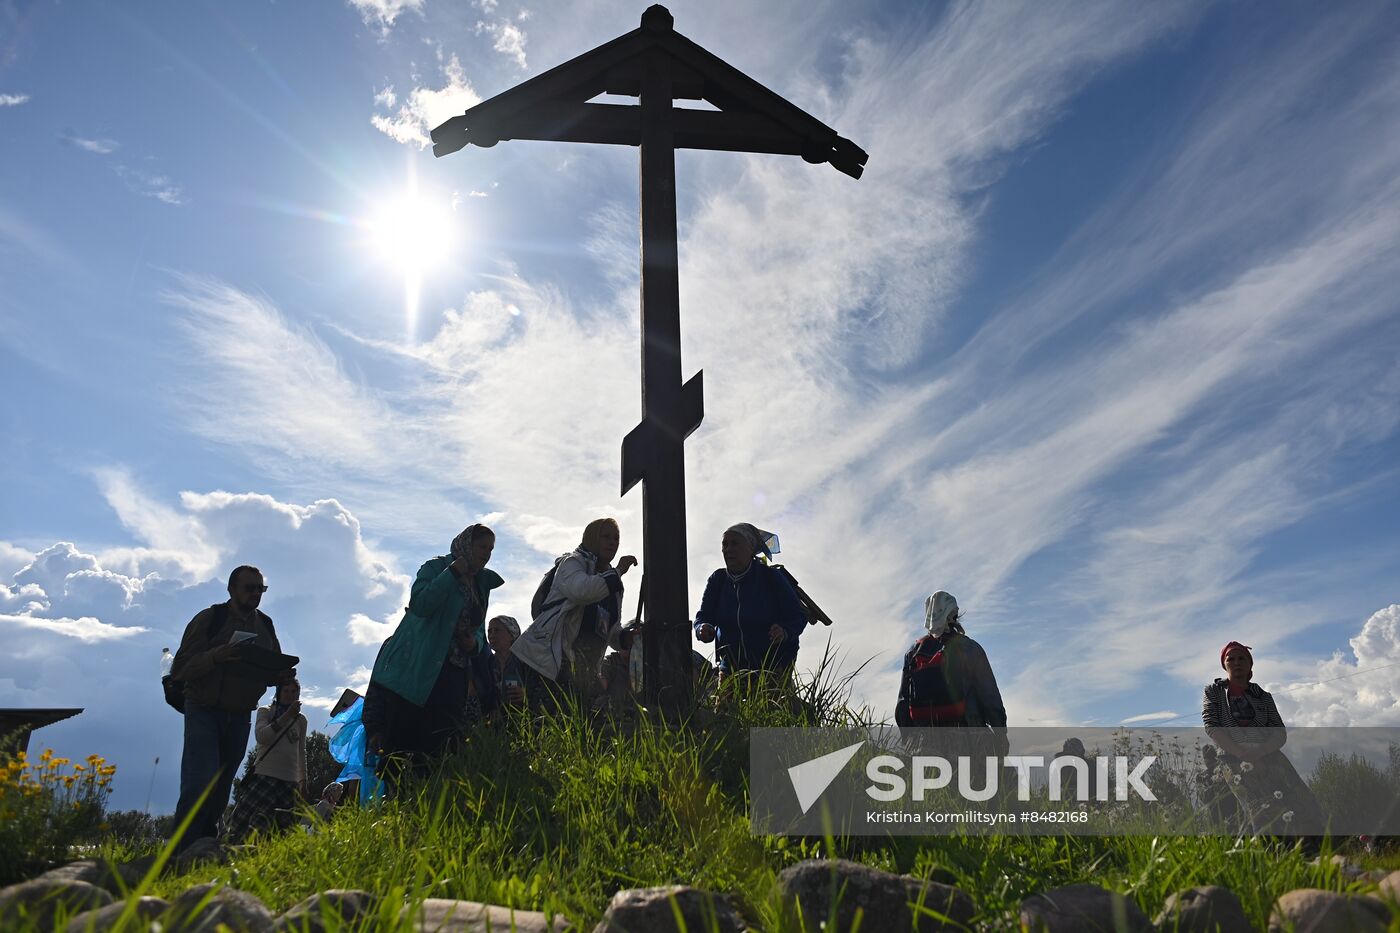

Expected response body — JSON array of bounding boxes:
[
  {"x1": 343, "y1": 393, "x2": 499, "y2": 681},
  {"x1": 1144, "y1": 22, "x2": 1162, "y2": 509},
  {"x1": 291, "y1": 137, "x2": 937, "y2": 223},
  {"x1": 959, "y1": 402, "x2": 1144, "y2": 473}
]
[{"x1": 370, "y1": 558, "x2": 505, "y2": 706}]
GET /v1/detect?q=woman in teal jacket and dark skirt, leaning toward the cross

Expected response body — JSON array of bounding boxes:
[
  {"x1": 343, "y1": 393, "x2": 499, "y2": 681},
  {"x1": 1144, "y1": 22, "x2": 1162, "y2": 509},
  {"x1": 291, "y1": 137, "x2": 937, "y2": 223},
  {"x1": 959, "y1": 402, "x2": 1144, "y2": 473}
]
[{"x1": 364, "y1": 525, "x2": 504, "y2": 756}]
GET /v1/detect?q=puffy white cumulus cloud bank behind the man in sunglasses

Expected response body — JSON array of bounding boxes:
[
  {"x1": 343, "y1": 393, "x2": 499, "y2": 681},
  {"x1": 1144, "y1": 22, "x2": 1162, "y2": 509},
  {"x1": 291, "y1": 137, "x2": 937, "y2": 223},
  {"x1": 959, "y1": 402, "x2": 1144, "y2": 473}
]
[{"x1": 0, "y1": 471, "x2": 409, "y2": 810}]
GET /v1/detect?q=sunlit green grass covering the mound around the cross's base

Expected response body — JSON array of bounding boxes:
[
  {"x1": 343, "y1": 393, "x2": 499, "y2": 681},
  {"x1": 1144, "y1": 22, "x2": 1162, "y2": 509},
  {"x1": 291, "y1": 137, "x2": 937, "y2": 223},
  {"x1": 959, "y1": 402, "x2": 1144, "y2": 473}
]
[{"x1": 10, "y1": 664, "x2": 1400, "y2": 933}]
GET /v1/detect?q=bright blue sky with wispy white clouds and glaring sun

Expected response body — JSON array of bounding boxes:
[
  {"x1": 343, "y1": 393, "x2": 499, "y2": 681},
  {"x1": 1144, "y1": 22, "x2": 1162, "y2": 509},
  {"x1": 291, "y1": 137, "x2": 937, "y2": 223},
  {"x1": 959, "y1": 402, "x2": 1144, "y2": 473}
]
[{"x1": 0, "y1": 0, "x2": 1400, "y2": 810}]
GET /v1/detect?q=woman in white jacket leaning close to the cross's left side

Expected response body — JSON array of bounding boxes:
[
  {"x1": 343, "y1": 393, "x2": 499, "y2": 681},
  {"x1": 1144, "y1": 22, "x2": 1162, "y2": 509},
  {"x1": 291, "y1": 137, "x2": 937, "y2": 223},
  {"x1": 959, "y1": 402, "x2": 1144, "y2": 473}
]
[{"x1": 511, "y1": 518, "x2": 637, "y2": 706}]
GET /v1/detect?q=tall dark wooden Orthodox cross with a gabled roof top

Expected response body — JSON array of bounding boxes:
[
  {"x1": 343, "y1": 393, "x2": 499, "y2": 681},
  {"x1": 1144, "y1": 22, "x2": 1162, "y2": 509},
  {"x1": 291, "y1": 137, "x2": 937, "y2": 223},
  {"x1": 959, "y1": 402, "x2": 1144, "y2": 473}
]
[{"x1": 433, "y1": 6, "x2": 867, "y2": 710}]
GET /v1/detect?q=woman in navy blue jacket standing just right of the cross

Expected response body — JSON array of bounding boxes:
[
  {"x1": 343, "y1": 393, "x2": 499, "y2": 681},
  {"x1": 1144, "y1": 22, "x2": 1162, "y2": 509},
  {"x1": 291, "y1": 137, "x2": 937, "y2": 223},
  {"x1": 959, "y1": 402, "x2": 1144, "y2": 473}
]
[{"x1": 694, "y1": 523, "x2": 806, "y2": 675}]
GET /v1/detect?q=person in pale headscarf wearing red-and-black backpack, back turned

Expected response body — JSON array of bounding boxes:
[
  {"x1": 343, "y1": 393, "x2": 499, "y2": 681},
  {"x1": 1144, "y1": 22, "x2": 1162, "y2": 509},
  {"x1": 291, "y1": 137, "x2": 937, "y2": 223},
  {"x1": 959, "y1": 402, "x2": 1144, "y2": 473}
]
[{"x1": 895, "y1": 590, "x2": 1007, "y2": 728}]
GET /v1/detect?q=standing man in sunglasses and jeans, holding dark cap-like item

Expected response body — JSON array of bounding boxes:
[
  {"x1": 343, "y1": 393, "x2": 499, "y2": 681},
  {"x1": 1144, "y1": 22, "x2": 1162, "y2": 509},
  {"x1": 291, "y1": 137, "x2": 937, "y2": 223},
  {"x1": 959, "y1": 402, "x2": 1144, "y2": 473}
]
[{"x1": 171, "y1": 565, "x2": 293, "y2": 848}]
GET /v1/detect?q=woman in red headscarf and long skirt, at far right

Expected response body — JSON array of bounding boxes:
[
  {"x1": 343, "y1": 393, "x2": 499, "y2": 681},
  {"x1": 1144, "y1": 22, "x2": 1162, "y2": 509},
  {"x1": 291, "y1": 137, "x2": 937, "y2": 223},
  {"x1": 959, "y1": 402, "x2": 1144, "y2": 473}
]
[{"x1": 1201, "y1": 642, "x2": 1323, "y2": 848}]
